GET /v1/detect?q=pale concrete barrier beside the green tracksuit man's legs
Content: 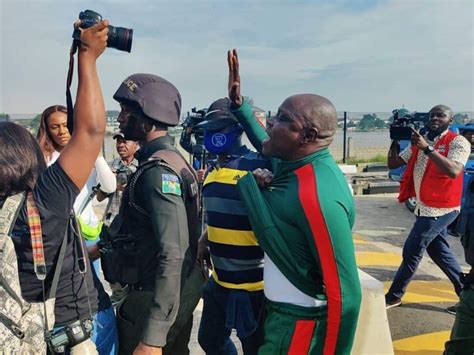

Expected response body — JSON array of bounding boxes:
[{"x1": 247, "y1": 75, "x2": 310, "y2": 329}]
[{"x1": 351, "y1": 269, "x2": 393, "y2": 355}]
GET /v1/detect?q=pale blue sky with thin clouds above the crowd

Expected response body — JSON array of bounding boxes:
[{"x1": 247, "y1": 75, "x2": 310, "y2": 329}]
[{"x1": 0, "y1": 0, "x2": 474, "y2": 113}]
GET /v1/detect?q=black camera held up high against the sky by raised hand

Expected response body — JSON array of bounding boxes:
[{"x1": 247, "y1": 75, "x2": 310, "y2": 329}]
[{"x1": 72, "y1": 10, "x2": 133, "y2": 53}]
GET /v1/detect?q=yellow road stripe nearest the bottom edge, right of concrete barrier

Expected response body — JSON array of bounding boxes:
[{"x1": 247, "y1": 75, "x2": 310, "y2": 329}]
[{"x1": 393, "y1": 330, "x2": 451, "y2": 355}]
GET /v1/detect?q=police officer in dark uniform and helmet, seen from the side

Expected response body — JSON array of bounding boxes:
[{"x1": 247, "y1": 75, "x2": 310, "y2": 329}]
[{"x1": 102, "y1": 74, "x2": 204, "y2": 354}]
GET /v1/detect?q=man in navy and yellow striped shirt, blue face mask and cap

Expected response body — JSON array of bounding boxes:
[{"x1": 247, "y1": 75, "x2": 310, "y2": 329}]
[{"x1": 198, "y1": 98, "x2": 270, "y2": 355}]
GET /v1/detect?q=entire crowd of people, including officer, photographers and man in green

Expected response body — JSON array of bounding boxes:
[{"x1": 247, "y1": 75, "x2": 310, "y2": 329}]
[{"x1": 0, "y1": 20, "x2": 474, "y2": 355}]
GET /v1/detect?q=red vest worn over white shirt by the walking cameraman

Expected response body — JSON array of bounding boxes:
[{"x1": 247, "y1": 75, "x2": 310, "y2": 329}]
[{"x1": 398, "y1": 131, "x2": 463, "y2": 208}]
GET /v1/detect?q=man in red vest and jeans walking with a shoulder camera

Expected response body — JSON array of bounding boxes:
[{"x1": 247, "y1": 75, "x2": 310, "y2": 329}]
[{"x1": 385, "y1": 105, "x2": 471, "y2": 313}]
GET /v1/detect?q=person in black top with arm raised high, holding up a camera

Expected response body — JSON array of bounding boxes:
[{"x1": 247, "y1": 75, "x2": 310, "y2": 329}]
[{"x1": 0, "y1": 21, "x2": 108, "y2": 354}]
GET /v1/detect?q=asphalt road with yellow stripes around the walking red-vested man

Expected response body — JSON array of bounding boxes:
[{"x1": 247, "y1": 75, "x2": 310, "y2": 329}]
[{"x1": 353, "y1": 194, "x2": 468, "y2": 355}]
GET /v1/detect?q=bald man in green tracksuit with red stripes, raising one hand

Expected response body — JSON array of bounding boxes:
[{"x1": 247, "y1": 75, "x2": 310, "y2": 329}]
[{"x1": 228, "y1": 49, "x2": 361, "y2": 355}]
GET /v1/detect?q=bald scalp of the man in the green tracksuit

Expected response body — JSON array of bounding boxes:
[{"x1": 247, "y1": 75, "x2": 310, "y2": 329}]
[{"x1": 280, "y1": 94, "x2": 337, "y2": 145}]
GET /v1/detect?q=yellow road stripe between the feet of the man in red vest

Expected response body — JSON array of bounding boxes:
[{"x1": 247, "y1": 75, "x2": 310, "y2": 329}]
[{"x1": 384, "y1": 280, "x2": 459, "y2": 303}]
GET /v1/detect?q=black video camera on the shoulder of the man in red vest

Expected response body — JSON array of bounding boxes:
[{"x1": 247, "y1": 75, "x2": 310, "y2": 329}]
[{"x1": 390, "y1": 110, "x2": 430, "y2": 141}]
